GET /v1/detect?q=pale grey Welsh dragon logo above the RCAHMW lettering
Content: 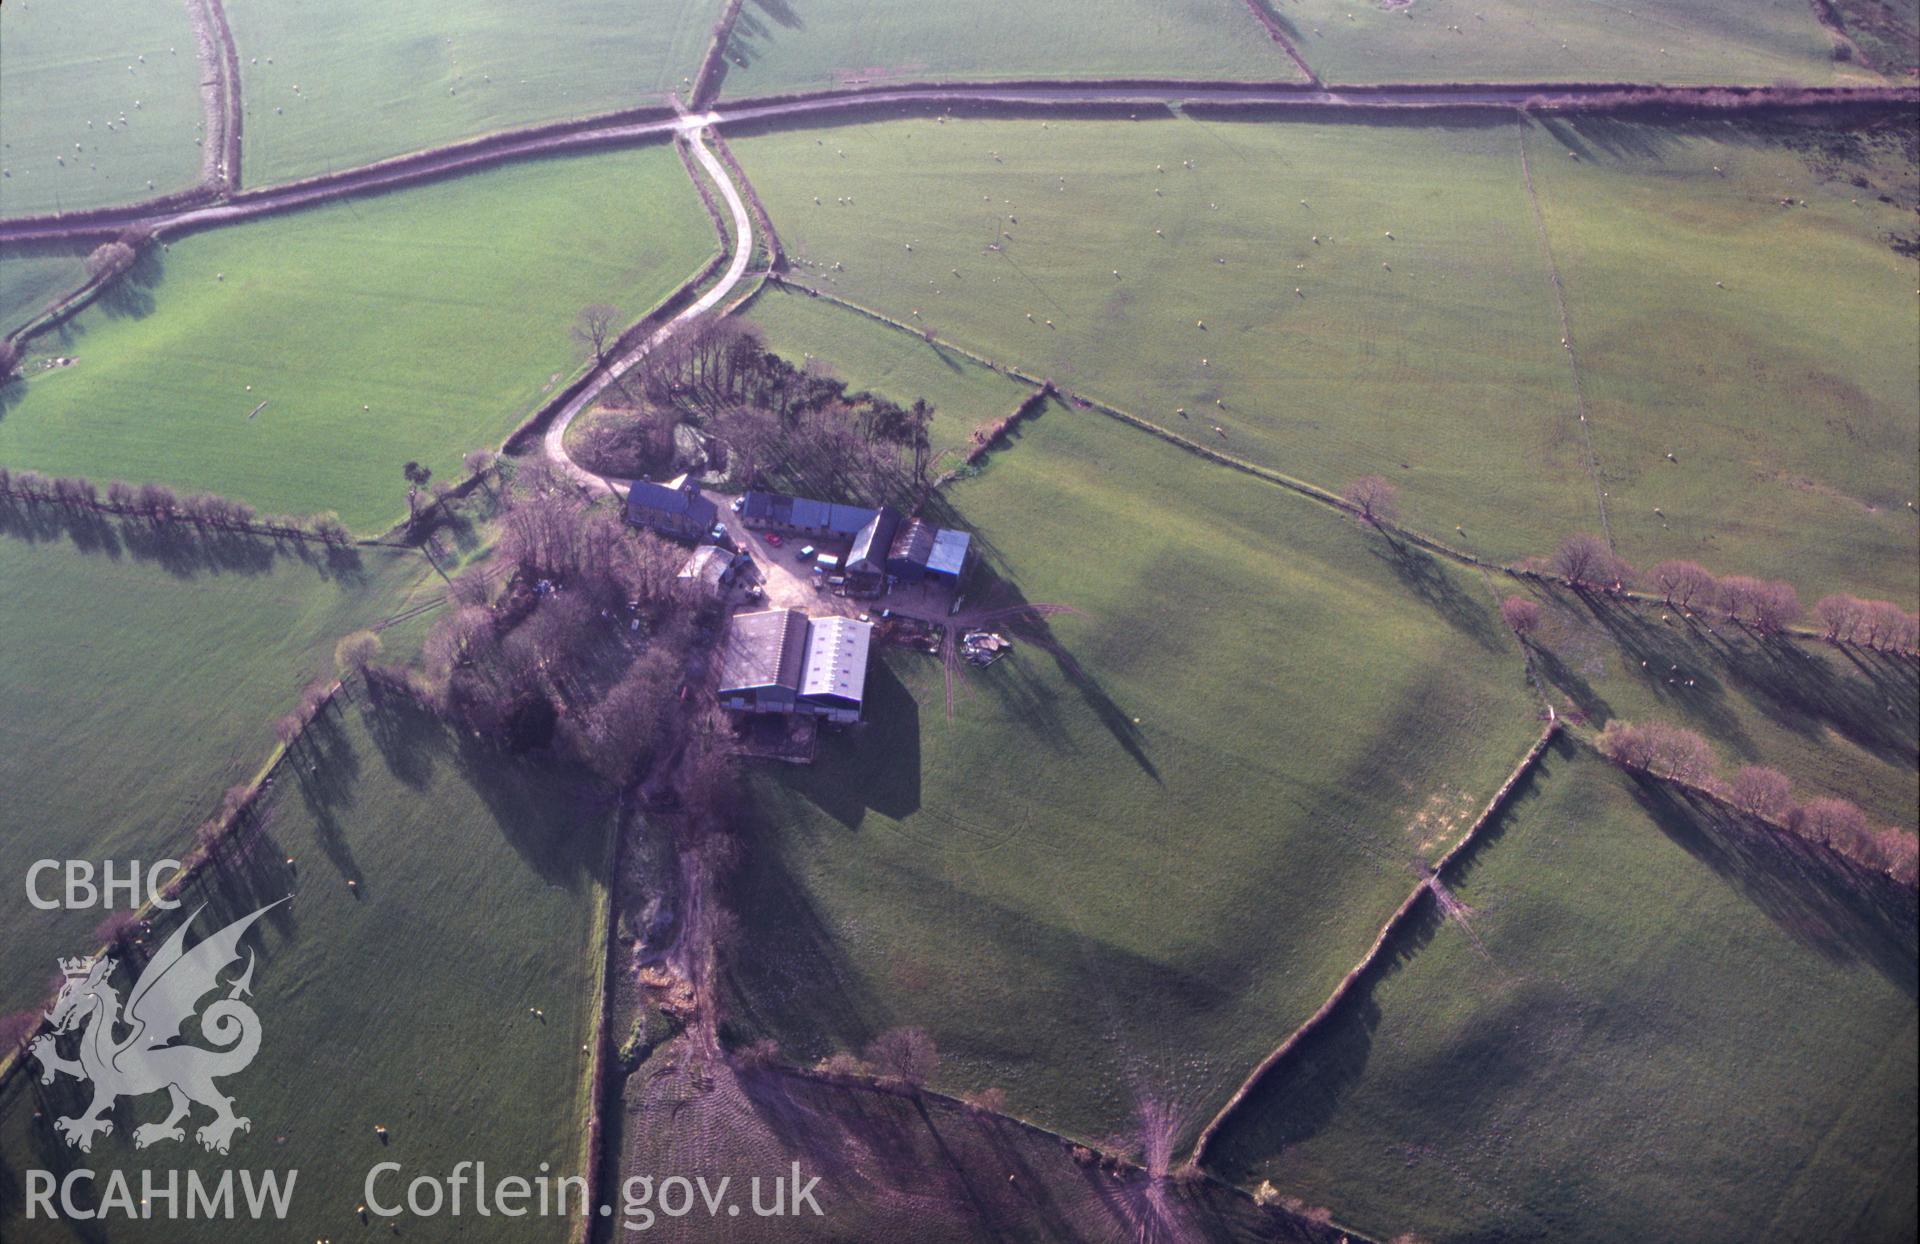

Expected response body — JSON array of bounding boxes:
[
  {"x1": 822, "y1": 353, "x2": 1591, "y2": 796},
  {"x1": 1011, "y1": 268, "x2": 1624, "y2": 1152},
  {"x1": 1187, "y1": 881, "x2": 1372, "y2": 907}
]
[{"x1": 31, "y1": 898, "x2": 286, "y2": 1154}]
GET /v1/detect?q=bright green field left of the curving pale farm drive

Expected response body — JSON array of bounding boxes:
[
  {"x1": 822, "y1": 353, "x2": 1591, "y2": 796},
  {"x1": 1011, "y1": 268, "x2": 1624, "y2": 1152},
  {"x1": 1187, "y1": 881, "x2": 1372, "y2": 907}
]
[{"x1": 0, "y1": 146, "x2": 714, "y2": 532}]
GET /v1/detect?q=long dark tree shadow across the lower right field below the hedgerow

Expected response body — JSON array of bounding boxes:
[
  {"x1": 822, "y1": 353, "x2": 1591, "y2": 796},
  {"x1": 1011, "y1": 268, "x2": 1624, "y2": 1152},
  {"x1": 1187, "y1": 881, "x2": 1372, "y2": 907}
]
[{"x1": 1634, "y1": 776, "x2": 1920, "y2": 998}]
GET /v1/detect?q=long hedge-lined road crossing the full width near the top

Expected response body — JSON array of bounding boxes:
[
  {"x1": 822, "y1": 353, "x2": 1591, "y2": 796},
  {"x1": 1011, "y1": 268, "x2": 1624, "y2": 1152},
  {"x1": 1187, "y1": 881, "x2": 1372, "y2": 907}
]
[{"x1": 0, "y1": 81, "x2": 1920, "y2": 246}]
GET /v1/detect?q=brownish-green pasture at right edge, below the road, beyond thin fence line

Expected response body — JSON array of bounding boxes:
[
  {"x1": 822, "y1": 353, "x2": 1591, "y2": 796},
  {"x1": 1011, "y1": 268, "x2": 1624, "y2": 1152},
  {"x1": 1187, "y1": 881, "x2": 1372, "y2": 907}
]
[{"x1": 1528, "y1": 119, "x2": 1920, "y2": 609}]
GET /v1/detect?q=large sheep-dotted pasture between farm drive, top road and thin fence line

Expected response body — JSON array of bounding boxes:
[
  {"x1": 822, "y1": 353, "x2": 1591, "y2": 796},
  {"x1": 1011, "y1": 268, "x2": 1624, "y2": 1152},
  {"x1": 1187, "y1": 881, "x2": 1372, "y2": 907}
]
[{"x1": 732, "y1": 113, "x2": 1596, "y2": 557}]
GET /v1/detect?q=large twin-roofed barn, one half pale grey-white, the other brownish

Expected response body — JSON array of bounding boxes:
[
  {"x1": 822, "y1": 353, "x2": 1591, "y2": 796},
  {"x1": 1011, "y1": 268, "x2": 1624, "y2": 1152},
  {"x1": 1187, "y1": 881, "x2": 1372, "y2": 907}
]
[{"x1": 720, "y1": 609, "x2": 874, "y2": 724}]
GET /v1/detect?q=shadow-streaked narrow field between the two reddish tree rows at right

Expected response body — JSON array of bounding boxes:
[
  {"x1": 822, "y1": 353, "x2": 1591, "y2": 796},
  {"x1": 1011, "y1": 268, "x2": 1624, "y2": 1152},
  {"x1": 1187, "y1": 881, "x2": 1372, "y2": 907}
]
[{"x1": 1512, "y1": 589, "x2": 1920, "y2": 829}]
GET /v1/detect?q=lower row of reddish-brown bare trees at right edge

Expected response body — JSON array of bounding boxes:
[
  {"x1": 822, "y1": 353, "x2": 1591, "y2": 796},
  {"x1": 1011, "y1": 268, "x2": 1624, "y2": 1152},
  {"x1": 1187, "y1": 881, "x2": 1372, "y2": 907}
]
[{"x1": 1596, "y1": 718, "x2": 1920, "y2": 885}]
